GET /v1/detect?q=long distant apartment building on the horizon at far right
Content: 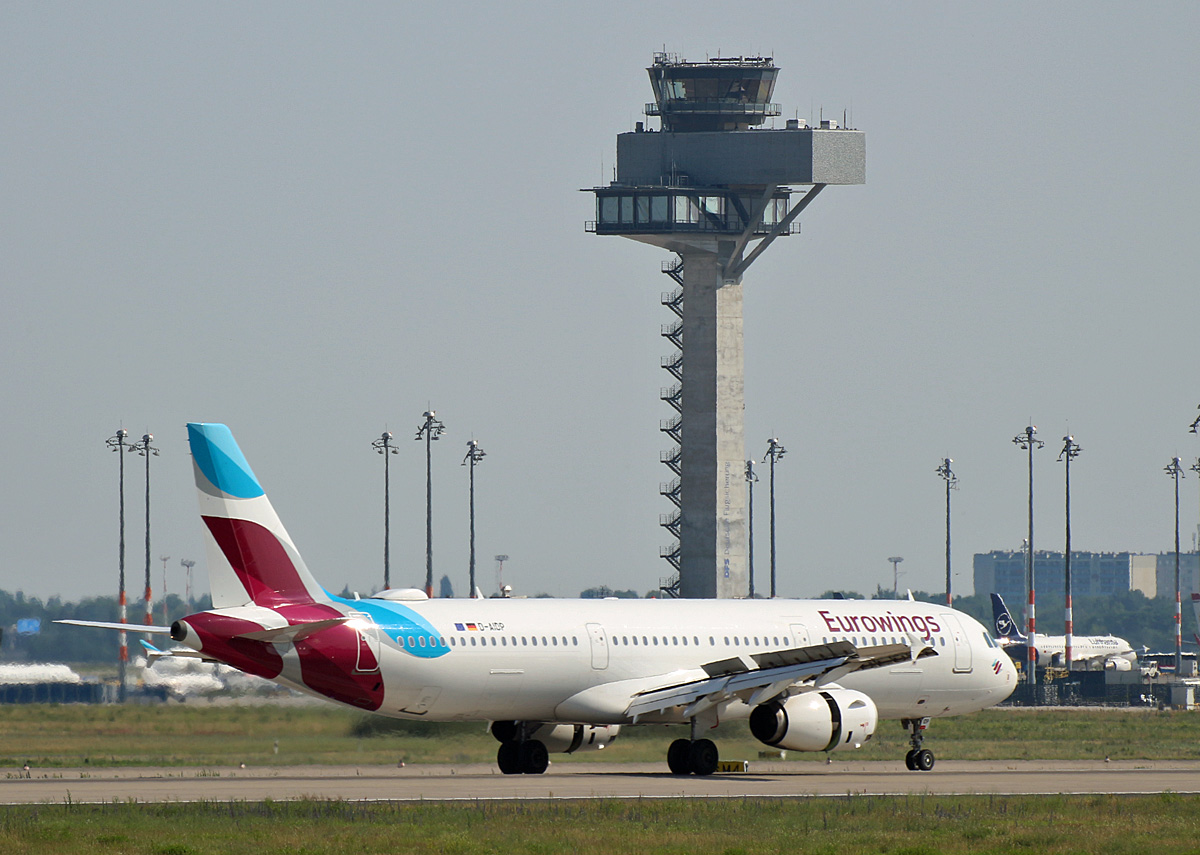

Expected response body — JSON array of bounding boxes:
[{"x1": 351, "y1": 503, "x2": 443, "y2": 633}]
[{"x1": 974, "y1": 550, "x2": 1200, "y2": 608}]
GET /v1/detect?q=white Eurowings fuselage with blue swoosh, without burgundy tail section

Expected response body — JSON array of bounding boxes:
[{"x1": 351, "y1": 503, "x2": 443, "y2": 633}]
[{"x1": 304, "y1": 598, "x2": 1016, "y2": 724}]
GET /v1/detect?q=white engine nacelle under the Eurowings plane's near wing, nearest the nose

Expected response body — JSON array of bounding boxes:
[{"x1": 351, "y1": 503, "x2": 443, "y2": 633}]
[{"x1": 750, "y1": 689, "x2": 880, "y2": 752}]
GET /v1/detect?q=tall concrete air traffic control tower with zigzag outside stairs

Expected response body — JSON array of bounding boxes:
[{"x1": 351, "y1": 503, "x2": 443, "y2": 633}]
[{"x1": 587, "y1": 54, "x2": 866, "y2": 598}]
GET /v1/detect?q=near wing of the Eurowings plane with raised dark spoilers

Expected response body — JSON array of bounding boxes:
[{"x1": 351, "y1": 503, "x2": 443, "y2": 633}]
[{"x1": 626, "y1": 638, "x2": 937, "y2": 723}]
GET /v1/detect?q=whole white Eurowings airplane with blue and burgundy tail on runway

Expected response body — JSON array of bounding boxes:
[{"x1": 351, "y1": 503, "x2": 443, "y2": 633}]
[{"x1": 65, "y1": 423, "x2": 1018, "y2": 776}]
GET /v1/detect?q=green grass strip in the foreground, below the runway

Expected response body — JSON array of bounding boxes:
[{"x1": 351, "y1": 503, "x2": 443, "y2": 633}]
[{"x1": 0, "y1": 794, "x2": 1200, "y2": 855}]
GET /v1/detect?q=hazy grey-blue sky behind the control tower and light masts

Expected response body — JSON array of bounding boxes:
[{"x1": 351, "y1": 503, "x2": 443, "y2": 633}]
[{"x1": 0, "y1": 0, "x2": 1200, "y2": 611}]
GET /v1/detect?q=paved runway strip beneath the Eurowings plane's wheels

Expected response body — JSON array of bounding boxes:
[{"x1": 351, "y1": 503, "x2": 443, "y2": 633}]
[{"x1": 0, "y1": 760, "x2": 1200, "y2": 805}]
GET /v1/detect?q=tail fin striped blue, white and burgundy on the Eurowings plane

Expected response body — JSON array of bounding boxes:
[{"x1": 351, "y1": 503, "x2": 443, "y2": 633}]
[{"x1": 187, "y1": 423, "x2": 326, "y2": 609}]
